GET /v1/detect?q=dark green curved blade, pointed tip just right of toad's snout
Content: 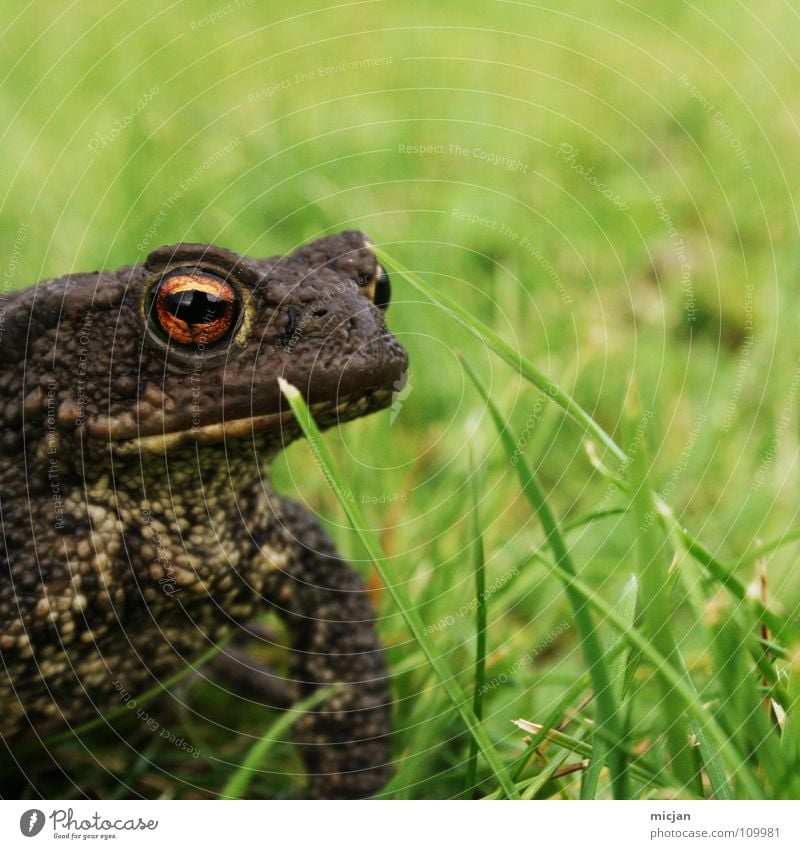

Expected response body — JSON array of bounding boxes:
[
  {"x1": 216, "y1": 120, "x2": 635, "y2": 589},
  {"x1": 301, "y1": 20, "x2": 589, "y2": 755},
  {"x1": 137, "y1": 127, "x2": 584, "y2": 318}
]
[{"x1": 462, "y1": 357, "x2": 627, "y2": 799}]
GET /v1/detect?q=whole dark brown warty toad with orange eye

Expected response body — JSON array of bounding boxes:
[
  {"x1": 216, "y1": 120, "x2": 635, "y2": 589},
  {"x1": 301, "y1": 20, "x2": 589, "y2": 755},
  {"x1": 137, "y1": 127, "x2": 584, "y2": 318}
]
[{"x1": 0, "y1": 233, "x2": 406, "y2": 796}]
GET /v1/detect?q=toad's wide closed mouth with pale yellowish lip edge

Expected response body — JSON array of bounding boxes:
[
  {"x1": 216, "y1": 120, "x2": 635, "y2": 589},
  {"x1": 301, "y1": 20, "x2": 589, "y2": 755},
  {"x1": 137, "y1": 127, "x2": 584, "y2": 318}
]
[{"x1": 104, "y1": 389, "x2": 394, "y2": 456}]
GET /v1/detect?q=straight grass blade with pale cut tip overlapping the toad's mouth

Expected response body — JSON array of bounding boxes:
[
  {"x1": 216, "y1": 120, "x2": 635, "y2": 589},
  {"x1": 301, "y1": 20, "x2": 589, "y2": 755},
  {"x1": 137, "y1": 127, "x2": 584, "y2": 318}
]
[{"x1": 278, "y1": 378, "x2": 519, "y2": 799}]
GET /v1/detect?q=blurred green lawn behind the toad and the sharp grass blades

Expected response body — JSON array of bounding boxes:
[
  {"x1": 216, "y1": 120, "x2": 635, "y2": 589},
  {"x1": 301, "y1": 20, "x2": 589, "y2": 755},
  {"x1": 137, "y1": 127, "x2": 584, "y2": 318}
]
[{"x1": 0, "y1": 0, "x2": 800, "y2": 798}]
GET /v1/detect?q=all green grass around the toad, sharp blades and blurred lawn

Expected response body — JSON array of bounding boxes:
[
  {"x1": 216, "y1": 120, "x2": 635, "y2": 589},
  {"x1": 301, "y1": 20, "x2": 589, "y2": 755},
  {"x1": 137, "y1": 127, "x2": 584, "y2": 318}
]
[{"x1": 0, "y1": 0, "x2": 800, "y2": 799}]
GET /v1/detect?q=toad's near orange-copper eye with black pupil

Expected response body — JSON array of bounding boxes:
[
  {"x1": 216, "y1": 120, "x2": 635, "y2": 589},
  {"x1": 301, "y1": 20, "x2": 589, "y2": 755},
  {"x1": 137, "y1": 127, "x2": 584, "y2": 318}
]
[{"x1": 153, "y1": 270, "x2": 239, "y2": 345}]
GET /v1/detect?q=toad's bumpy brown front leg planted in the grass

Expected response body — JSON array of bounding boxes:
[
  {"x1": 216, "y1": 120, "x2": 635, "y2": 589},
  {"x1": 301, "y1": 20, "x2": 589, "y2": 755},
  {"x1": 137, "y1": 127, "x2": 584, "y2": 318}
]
[{"x1": 265, "y1": 500, "x2": 391, "y2": 799}]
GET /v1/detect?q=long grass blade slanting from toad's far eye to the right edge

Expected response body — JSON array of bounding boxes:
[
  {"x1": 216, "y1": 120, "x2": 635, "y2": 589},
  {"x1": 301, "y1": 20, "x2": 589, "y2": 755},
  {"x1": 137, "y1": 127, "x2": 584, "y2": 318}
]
[{"x1": 370, "y1": 245, "x2": 800, "y2": 638}]
